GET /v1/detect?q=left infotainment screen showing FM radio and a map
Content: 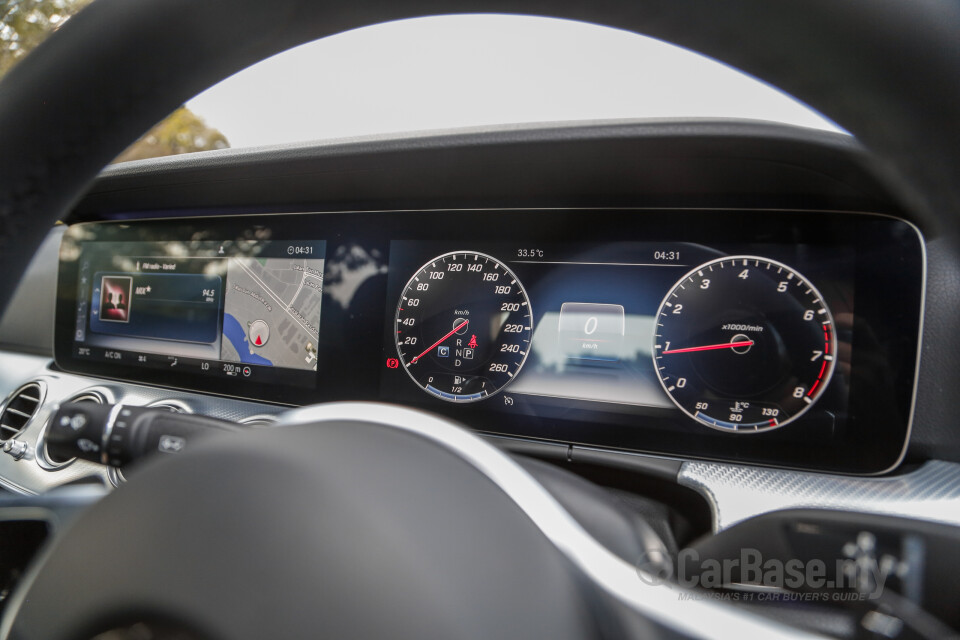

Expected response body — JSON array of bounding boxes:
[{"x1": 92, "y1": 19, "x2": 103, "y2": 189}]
[{"x1": 74, "y1": 241, "x2": 326, "y2": 384}]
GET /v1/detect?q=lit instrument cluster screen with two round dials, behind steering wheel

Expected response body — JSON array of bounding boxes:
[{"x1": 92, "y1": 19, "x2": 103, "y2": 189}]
[{"x1": 384, "y1": 241, "x2": 856, "y2": 435}]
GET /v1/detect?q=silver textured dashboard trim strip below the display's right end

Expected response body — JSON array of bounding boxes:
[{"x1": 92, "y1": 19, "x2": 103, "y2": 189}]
[{"x1": 677, "y1": 461, "x2": 960, "y2": 531}]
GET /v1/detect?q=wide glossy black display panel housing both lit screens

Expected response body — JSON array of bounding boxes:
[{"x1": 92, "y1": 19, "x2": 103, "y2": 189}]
[{"x1": 55, "y1": 207, "x2": 925, "y2": 474}]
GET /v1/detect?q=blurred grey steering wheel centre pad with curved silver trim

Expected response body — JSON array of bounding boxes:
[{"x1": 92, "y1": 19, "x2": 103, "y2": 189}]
[{"x1": 0, "y1": 402, "x2": 806, "y2": 640}]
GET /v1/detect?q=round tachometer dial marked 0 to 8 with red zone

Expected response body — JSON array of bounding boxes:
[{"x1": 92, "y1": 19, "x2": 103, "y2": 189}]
[{"x1": 653, "y1": 256, "x2": 836, "y2": 432}]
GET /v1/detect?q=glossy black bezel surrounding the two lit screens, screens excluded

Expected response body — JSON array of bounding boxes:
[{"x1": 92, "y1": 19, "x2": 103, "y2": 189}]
[{"x1": 56, "y1": 209, "x2": 925, "y2": 473}]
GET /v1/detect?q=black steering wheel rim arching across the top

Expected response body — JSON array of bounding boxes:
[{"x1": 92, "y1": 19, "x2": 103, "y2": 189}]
[{"x1": 0, "y1": 0, "x2": 960, "y2": 636}]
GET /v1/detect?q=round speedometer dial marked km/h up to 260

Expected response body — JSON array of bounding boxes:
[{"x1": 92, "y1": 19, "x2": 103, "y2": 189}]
[{"x1": 396, "y1": 251, "x2": 533, "y2": 402}]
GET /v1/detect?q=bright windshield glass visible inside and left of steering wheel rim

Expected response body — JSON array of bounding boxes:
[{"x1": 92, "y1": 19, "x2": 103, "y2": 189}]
[{"x1": 0, "y1": 7, "x2": 840, "y2": 162}]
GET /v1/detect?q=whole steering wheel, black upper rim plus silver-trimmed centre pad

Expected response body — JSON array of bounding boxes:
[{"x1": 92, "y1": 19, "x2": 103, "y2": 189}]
[{"x1": 0, "y1": 0, "x2": 960, "y2": 640}]
